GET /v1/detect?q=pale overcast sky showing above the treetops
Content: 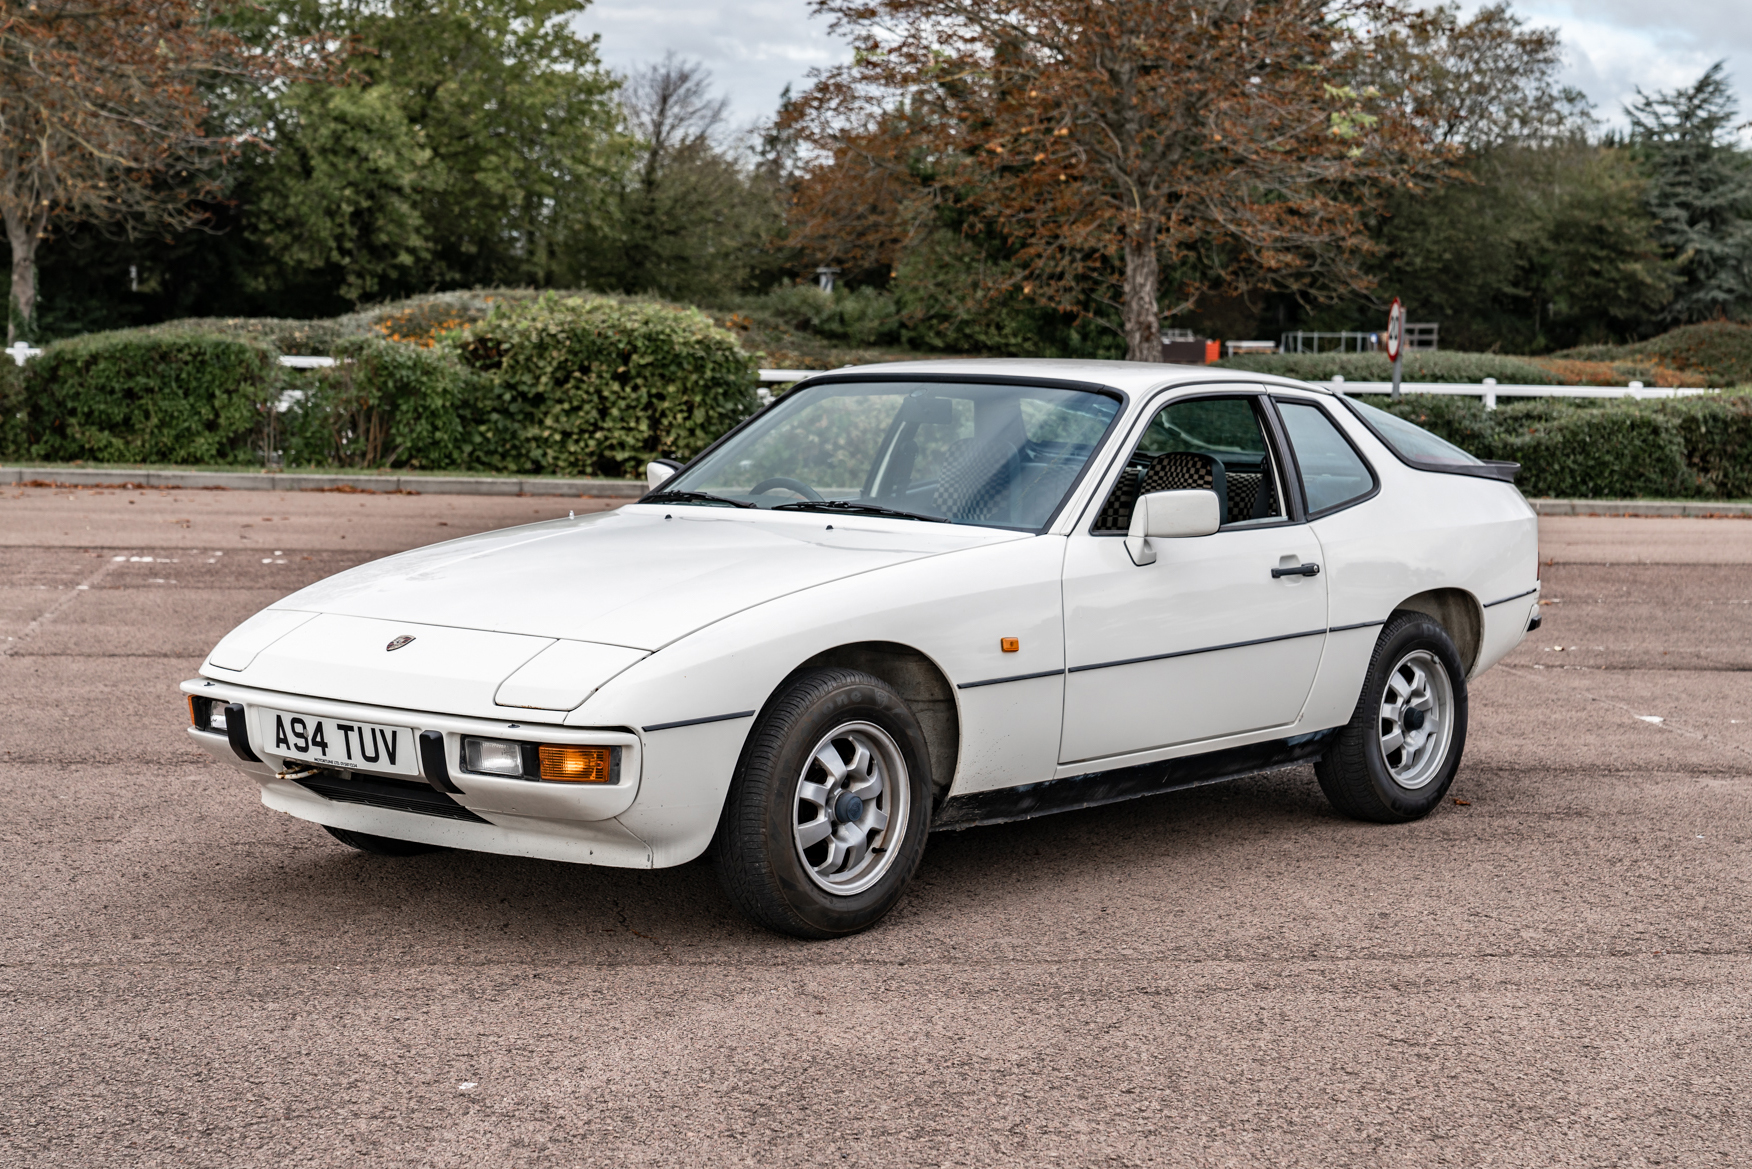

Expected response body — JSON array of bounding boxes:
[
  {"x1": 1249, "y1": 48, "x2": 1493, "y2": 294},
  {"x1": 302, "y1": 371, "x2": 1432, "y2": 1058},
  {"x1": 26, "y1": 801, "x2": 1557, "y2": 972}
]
[{"x1": 583, "y1": 0, "x2": 1752, "y2": 137}]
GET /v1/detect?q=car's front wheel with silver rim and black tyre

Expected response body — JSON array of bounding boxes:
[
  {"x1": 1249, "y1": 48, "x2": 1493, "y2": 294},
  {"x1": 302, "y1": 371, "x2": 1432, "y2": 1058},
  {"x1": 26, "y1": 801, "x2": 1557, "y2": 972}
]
[{"x1": 713, "y1": 668, "x2": 932, "y2": 938}]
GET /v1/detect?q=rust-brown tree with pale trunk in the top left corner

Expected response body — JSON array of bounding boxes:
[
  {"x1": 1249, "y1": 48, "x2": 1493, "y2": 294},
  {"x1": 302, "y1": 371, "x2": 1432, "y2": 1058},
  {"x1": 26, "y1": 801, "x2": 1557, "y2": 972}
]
[{"x1": 0, "y1": 0, "x2": 286, "y2": 340}]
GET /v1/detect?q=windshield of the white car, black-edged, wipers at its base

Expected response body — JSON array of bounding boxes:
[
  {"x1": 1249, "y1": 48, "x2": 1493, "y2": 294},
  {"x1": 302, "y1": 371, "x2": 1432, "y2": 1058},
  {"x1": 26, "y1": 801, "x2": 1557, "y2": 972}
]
[{"x1": 653, "y1": 382, "x2": 1120, "y2": 529}]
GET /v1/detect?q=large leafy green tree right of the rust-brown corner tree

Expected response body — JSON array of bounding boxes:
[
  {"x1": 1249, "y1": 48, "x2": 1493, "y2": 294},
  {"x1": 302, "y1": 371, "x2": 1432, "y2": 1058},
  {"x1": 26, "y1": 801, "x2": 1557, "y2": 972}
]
[{"x1": 254, "y1": 0, "x2": 627, "y2": 300}]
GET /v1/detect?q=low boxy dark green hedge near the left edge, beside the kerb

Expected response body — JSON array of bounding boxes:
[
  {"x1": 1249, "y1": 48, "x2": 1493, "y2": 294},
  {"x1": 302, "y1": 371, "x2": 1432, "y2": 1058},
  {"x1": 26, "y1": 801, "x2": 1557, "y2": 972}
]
[{"x1": 19, "y1": 331, "x2": 282, "y2": 463}]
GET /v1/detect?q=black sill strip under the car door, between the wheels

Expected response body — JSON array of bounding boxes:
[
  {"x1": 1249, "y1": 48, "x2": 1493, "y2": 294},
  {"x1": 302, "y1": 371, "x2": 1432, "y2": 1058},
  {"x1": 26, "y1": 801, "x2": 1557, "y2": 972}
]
[{"x1": 930, "y1": 727, "x2": 1337, "y2": 832}]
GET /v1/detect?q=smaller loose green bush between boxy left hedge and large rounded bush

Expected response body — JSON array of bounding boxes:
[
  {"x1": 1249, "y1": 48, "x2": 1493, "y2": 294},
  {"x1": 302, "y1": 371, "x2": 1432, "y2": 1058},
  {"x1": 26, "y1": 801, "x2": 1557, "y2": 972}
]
[{"x1": 280, "y1": 337, "x2": 480, "y2": 470}]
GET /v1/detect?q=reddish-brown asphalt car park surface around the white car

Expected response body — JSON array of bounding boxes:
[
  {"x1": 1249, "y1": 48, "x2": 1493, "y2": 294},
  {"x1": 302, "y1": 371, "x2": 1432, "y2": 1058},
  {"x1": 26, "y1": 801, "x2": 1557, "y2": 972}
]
[{"x1": 0, "y1": 487, "x2": 1752, "y2": 1169}]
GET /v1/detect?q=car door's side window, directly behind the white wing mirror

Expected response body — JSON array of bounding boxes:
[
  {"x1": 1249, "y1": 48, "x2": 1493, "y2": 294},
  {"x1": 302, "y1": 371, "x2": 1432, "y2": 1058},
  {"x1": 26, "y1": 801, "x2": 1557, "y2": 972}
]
[{"x1": 1095, "y1": 396, "x2": 1286, "y2": 531}]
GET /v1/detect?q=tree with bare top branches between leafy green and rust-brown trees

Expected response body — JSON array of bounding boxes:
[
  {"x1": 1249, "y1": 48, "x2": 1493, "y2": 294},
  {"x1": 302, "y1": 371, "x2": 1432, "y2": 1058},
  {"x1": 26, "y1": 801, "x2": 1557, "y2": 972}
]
[{"x1": 580, "y1": 53, "x2": 780, "y2": 298}]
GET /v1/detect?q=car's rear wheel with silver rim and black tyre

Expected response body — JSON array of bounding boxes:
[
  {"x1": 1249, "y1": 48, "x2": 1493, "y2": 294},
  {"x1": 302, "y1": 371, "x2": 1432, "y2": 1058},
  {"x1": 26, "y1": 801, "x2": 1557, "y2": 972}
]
[{"x1": 1314, "y1": 613, "x2": 1466, "y2": 824}]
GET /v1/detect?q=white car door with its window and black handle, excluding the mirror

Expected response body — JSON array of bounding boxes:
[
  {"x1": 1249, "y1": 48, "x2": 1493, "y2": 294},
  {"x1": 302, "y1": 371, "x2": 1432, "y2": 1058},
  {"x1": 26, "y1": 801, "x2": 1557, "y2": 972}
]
[{"x1": 1060, "y1": 389, "x2": 1326, "y2": 764}]
